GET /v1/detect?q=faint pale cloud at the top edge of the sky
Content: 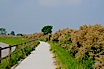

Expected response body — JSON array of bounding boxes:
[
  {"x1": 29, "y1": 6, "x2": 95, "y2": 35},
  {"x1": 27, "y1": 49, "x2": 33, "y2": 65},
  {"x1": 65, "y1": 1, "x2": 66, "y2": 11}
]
[{"x1": 37, "y1": 0, "x2": 82, "y2": 6}]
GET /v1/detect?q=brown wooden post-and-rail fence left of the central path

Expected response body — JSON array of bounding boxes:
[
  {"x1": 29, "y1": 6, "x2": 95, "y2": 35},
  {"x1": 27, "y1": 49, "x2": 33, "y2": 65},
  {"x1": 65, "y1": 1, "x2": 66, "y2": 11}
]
[{"x1": 0, "y1": 40, "x2": 36, "y2": 66}]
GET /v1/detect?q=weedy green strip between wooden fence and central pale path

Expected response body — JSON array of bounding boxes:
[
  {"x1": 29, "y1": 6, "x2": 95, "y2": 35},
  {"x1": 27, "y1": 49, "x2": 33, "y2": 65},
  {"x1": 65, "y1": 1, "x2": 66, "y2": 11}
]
[{"x1": 0, "y1": 41, "x2": 39, "y2": 69}]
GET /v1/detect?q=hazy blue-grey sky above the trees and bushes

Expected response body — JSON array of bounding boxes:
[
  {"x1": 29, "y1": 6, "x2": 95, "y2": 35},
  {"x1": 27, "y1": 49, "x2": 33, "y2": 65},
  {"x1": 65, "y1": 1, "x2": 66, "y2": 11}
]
[{"x1": 0, "y1": 0, "x2": 104, "y2": 34}]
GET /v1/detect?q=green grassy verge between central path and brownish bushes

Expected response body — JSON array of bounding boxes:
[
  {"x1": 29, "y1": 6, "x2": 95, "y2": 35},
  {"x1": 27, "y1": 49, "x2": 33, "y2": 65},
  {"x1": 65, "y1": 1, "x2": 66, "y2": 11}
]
[{"x1": 49, "y1": 42, "x2": 93, "y2": 69}]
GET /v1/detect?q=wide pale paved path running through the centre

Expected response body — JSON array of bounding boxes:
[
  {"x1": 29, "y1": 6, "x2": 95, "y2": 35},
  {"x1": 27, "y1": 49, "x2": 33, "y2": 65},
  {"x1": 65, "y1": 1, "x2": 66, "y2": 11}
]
[{"x1": 15, "y1": 42, "x2": 55, "y2": 69}]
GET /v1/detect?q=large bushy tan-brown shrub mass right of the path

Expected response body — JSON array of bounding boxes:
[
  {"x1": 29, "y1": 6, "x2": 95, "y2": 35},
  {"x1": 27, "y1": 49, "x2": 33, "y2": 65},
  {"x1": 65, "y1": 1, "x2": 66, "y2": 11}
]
[{"x1": 51, "y1": 24, "x2": 104, "y2": 69}]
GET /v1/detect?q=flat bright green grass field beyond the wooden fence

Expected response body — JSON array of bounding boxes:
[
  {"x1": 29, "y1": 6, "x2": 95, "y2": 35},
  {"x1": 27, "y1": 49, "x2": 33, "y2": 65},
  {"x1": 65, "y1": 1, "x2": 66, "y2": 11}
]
[{"x1": 0, "y1": 37, "x2": 26, "y2": 45}]
